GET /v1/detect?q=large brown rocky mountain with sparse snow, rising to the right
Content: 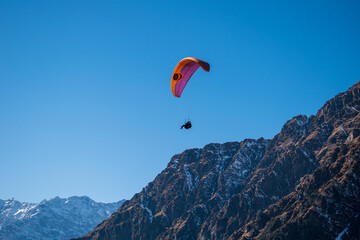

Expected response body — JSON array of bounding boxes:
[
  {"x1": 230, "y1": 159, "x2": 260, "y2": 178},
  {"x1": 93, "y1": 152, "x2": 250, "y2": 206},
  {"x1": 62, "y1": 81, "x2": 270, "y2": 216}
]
[{"x1": 77, "y1": 82, "x2": 360, "y2": 239}]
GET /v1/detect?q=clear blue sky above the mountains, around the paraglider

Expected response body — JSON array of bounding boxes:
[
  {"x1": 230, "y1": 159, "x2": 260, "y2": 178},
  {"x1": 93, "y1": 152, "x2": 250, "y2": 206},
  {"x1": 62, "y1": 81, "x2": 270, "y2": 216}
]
[{"x1": 0, "y1": 0, "x2": 360, "y2": 202}]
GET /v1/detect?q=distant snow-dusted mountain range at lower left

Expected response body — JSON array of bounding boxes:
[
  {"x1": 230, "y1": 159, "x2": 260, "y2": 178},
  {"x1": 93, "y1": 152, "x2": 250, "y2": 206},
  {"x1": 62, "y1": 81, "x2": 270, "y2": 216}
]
[{"x1": 0, "y1": 197, "x2": 125, "y2": 240}]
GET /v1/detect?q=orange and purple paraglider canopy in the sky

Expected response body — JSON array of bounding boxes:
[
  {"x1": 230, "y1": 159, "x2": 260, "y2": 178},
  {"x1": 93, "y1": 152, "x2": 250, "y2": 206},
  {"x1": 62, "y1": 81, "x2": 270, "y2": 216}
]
[{"x1": 171, "y1": 57, "x2": 210, "y2": 97}]
